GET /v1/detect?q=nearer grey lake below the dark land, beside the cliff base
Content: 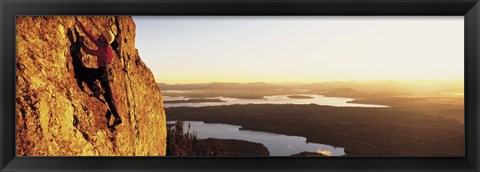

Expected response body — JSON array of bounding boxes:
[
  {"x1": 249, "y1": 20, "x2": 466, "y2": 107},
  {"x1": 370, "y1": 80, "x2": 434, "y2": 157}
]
[{"x1": 167, "y1": 121, "x2": 345, "y2": 156}]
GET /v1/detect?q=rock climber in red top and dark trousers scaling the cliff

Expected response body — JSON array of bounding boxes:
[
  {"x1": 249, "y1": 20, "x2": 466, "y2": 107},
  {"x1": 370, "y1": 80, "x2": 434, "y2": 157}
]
[{"x1": 78, "y1": 22, "x2": 122, "y2": 128}]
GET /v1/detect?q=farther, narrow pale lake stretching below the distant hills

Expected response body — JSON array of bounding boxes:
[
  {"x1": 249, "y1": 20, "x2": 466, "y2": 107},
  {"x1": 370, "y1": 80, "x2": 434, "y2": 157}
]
[{"x1": 163, "y1": 94, "x2": 389, "y2": 108}]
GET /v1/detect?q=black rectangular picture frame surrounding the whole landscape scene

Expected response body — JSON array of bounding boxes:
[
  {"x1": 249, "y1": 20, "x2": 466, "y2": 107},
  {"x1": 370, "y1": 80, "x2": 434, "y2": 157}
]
[{"x1": 0, "y1": 0, "x2": 480, "y2": 172}]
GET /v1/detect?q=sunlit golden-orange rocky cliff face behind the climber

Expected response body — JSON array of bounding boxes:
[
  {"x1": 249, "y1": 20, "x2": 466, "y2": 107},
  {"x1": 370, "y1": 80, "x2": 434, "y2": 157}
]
[{"x1": 16, "y1": 16, "x2": 166, "y2": 156}]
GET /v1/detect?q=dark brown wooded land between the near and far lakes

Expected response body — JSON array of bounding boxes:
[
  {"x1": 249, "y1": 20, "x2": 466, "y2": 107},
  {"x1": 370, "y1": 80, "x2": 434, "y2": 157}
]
[{"x1": 166, "y1": 104, "x2": 464, "y2": 156}]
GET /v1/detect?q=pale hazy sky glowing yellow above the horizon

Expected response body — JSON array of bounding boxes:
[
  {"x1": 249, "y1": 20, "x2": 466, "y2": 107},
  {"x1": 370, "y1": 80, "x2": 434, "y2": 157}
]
[{"x1": 133, "y1": 16, "x2": 464, "y2": 83}]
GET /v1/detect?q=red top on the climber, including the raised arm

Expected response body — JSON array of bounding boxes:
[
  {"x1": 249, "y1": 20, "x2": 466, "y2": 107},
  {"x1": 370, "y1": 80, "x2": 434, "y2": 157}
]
[{"x1": 82, "y1": 27, "x2": 113, "y2": 67}]
